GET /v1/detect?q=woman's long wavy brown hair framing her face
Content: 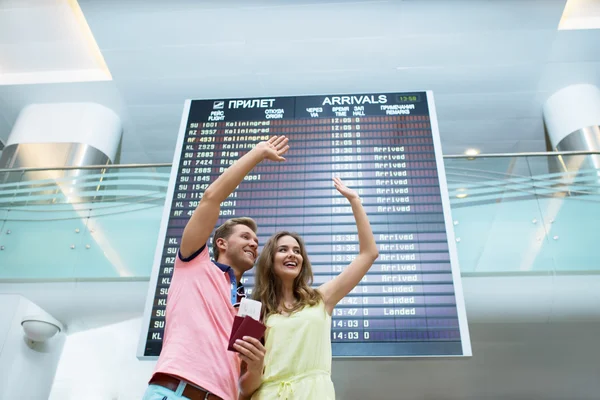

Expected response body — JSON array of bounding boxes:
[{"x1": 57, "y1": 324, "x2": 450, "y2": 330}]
[{"x1": 253, "y1": 231, "x2": 321, "y2": 320}]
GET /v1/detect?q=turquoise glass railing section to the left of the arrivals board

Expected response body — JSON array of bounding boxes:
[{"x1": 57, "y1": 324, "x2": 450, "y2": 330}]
[{"x1": 0, "y1": 166, "x2": 171, "y2": 280}]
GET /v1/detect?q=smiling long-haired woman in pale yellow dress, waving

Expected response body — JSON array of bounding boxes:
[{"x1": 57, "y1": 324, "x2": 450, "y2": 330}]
[{"x1": 246, "y1": 178, "x2": 379, "y2": 400}]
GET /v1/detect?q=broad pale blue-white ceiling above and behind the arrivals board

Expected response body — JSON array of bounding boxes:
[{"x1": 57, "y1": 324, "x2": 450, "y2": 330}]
[{"x1": 0, "y1": 0, "x2": 600, "y2": 163}]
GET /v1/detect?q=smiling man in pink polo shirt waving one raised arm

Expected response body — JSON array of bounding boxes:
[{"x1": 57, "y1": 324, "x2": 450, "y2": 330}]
[{"x1": 144, "y1": 136, "x2": 289, "y2": 400}]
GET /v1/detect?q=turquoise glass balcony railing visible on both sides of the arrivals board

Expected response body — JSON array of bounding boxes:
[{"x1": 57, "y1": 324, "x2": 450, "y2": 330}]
[{"x1": 0, "y1": 153, "x2": 600, "y2": 281}]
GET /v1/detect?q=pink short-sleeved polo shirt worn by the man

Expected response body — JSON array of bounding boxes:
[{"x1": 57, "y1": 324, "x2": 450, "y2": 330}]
[{"x1": 154, "y1": 246, "x2": 243, "y2": 400}]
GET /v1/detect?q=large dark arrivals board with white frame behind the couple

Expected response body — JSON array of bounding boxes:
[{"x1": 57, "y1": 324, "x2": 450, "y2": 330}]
[{"x1": 138, "y1": 92, "x2": 471, "y2": 357}]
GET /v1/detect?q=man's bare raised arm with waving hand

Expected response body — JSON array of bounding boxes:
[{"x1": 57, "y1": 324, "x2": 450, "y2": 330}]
[{"x1": 180, "y1": 136, "x2": 289, "y2": 258}]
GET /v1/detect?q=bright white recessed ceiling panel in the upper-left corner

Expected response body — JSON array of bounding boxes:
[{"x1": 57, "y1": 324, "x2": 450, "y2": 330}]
[{"x1": 0, "y1": 0, "x2": 110, "y2": 85}]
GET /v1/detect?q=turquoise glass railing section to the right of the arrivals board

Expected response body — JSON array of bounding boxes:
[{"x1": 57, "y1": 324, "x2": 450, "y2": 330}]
[{"x1": 445, "y1": 154, "x2": 600, "y2": 273}]
